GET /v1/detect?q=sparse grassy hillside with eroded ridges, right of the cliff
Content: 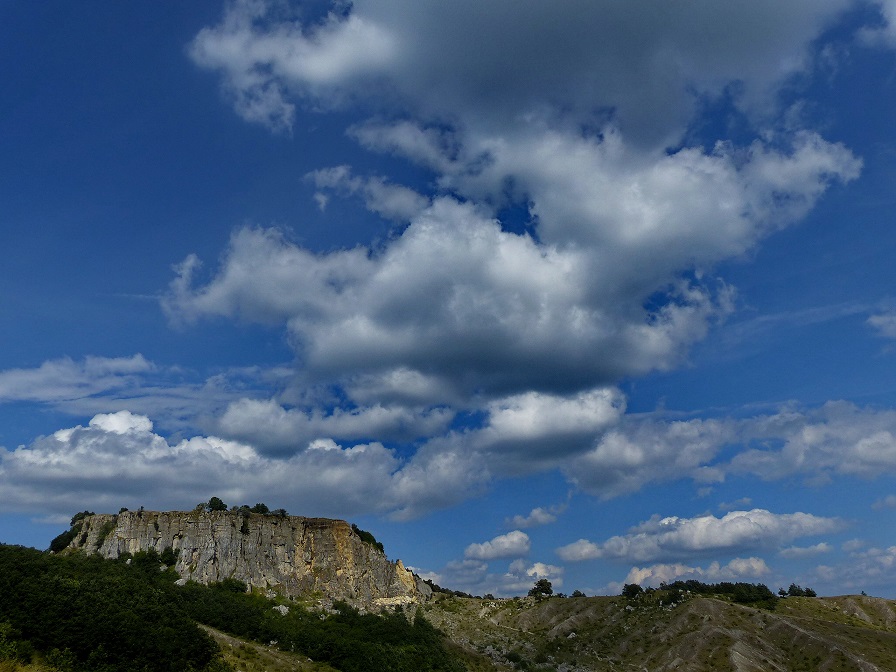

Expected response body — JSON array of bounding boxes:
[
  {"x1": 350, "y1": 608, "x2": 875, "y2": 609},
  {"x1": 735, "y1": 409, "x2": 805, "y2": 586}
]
[{"x1": 424, "y1": 597, "x2": 896, "y2": 672}]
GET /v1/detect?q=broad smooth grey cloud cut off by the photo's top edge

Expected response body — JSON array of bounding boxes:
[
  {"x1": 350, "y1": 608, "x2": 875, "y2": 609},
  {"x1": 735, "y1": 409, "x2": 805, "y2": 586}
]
[{"x1": 191, "y1": 0, "x2": 851, "y2": 142}]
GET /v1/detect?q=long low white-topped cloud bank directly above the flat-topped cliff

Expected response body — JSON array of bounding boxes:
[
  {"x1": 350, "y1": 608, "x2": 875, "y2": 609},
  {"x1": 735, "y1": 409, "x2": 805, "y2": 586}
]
[{"x1": 0, "y1": 411, "x2": 488, "y2": 517}]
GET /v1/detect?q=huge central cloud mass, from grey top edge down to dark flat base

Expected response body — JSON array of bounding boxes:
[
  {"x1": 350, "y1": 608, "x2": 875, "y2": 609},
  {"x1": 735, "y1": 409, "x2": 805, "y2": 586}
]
[{"x1": 173, "y1": 0, "x2": 861, "y2": 420}]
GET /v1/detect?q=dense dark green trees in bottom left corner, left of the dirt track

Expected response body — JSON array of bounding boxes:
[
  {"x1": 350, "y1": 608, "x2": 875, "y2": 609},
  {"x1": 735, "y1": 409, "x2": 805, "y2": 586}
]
[{"x1": 0, "y1": 545, "x2": 221, "y2": 672}]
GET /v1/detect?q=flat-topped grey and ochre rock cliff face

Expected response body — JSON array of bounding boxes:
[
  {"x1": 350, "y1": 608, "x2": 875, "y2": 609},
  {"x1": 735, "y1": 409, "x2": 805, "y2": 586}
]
[{"x1": 68, "y1": 509, "x2": 432, "y2": 605}]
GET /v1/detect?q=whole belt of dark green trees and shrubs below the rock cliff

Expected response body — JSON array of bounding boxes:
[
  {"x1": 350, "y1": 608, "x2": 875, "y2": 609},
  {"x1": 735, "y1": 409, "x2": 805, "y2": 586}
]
[{"x1": 0, "y1": 545, "x2": 464, "y2": 672}]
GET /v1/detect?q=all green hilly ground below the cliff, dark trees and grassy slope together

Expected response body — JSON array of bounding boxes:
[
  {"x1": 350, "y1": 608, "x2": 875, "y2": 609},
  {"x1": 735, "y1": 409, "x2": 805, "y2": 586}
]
[{"x1": 0, "y1": 545, "x2": 896, "y2": 672}]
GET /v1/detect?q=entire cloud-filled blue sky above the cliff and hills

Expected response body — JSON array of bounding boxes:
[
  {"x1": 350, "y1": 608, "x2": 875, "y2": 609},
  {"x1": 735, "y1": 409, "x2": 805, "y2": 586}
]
[{"x1": 0, "y1": 0, "x2": 896, "y2": 597}]
